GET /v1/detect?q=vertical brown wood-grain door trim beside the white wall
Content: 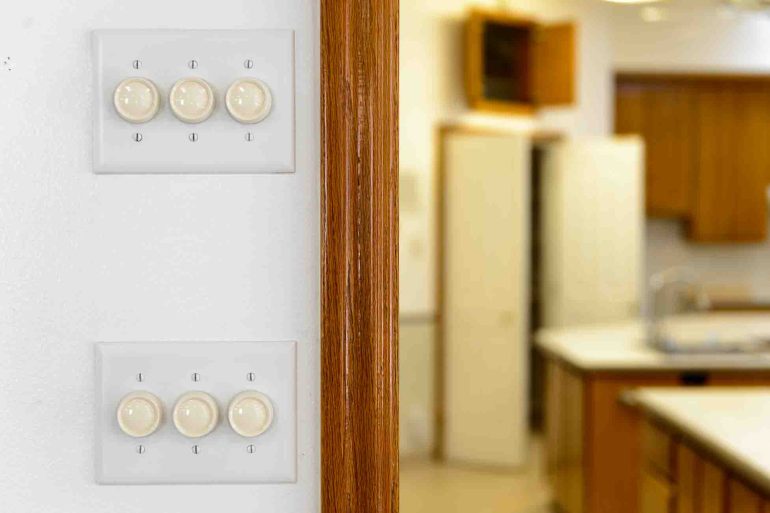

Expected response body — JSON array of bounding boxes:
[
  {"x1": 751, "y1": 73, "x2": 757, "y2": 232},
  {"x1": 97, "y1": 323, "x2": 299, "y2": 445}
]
[{"x1": 321, "y1": 0, "x2": 398, "y2": 513}]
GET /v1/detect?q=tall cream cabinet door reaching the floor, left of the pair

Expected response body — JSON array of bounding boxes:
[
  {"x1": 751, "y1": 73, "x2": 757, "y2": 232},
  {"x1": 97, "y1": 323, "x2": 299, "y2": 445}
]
[{"x1": 438, "y1": 127, "x2": 531, "y2": 467}]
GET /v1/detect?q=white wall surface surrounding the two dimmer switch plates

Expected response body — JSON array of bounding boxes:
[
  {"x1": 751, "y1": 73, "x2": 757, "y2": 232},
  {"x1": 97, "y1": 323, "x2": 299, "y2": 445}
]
[{"x1": 0, "y1": 0, "x2": 319, "y2": 513}]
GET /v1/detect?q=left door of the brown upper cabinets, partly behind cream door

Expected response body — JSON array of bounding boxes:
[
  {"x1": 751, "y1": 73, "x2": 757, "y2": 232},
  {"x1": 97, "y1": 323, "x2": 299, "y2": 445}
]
[{"x1": 615, "y1": 78, "x2": 696, "y2": 217}]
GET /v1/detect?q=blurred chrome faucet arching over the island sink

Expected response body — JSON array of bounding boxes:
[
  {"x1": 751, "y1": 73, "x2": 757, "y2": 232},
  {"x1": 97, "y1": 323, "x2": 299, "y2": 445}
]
[{"x1": 647, "y1": 267, "x2": 711, "y2": 349}]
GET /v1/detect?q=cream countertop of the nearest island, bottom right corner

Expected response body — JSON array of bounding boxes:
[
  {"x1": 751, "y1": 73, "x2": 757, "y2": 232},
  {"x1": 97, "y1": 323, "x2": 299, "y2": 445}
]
[{"x1": 629, "y1": 388, "x2": 770, "y2": 495}]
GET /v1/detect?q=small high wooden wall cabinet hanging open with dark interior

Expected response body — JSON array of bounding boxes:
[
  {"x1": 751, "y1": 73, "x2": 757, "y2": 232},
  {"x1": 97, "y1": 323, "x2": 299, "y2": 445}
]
[{"x1": 465, "y1": 9, "x2": 575, "y2": 114}]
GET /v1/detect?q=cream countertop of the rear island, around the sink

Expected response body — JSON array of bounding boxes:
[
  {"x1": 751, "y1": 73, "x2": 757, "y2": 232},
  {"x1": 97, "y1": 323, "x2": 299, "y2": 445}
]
[{"x1": 535, "y1": 316, "x2": 770, "y2": 372}]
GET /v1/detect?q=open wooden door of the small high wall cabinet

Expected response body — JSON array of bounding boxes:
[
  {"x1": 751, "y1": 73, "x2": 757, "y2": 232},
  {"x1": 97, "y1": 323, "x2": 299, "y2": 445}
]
[{"x1": 532, "y1": 23, "x2": 575, "y2": 106}]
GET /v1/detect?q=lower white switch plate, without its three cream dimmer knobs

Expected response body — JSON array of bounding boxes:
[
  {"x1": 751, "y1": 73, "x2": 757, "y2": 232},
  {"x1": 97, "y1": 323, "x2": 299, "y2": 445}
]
[{"x1": 96, "y1": 342, "x2": 297, "y2": 484}]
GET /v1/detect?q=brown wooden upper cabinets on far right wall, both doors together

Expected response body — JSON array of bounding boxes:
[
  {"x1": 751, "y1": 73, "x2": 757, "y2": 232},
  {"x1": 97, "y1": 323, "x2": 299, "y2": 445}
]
[{"x1": 615, "y1": 74, "x2": 770, "y2": 242}]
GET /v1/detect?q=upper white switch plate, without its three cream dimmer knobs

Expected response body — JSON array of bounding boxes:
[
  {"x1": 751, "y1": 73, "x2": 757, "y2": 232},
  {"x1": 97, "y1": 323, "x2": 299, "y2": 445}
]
[{"x1": 93, "y1": 30, "x2": 294, "y2": 173}]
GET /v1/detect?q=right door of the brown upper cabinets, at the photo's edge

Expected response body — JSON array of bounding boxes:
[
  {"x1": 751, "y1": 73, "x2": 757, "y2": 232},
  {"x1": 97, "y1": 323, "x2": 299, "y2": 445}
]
[{"x1": 690, "y1": 82, "x2": 770, "y2": 242}]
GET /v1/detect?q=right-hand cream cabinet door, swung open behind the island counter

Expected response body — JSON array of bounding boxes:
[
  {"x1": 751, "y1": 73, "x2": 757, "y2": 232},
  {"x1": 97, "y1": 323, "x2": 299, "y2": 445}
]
[{"x1": 538, "y1": 137, "x2": 644, "y2": 327}]
